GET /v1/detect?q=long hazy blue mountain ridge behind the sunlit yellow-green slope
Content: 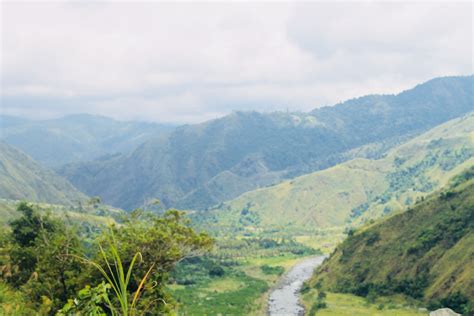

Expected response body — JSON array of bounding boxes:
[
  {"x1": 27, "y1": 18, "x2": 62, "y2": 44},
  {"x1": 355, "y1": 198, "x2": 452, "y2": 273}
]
[{"x1": 60, "y1": 76, "x2": 474, "y2": 209}]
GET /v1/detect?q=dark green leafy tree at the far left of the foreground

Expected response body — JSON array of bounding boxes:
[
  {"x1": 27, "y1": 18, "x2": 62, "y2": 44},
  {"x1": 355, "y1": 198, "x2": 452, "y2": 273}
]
[{"x1": 8, "y1": 203, "x2": 82, "y2": 311}]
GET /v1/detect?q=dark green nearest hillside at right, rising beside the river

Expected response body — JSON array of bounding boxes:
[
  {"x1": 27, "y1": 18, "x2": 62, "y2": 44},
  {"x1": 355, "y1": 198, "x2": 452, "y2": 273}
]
[{"x1": 311, "y1": 167, "x2": 474, "y2": 314}]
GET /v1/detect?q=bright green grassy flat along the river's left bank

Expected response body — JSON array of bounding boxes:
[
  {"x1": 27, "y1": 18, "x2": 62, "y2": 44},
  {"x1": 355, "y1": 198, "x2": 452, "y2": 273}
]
[{"x1": 169, "y1": 254, "x2": 312, "y2": 315}]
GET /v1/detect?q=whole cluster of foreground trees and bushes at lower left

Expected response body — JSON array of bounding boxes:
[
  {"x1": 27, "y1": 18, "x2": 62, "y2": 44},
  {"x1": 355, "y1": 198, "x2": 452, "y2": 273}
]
[{"x1": 0, "y1": 203, "x2": 213, "y2": 315}]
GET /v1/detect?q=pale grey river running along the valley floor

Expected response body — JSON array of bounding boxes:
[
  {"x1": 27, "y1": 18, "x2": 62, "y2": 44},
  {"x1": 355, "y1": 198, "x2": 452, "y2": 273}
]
[{"x1": 268, "y1": 256, "x2": 325, "y2": 316}]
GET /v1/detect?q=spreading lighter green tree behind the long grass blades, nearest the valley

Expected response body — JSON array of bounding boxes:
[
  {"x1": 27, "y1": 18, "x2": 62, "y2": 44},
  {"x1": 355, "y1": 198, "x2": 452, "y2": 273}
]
[{"x1": 65, "y1": 210, "x2": 213, "y2": 315}]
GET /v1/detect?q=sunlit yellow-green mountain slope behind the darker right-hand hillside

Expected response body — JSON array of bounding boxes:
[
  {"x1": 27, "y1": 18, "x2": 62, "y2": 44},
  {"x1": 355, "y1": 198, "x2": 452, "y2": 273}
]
[{"x1": 207, "y1": 114, "x2": 474, "y2": 230}]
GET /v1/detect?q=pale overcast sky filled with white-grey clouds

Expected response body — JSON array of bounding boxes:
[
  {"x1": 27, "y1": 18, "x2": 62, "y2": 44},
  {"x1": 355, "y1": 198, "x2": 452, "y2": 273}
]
[{"x1": 0, "y1": 1, "x2": 474, "y2": 123}]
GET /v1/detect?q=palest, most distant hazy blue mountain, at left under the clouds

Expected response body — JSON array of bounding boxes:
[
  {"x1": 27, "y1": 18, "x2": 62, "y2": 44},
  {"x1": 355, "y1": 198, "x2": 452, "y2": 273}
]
[{"x1": 0, "y1": 114, "x2": 174, "y2": 167}]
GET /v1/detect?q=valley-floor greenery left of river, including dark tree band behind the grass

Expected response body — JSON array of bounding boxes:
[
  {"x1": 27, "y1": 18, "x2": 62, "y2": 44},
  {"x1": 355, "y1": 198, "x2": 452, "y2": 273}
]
[{"x1": 165, "y1": 239, "x2": 319, "y2": 315}]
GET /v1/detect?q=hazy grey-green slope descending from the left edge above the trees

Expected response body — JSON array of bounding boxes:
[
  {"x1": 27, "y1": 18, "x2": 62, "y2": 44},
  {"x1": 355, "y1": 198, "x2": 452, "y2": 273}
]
[{"x1": 0, "y1": 142, "x2": 87, "y2": 205}]
